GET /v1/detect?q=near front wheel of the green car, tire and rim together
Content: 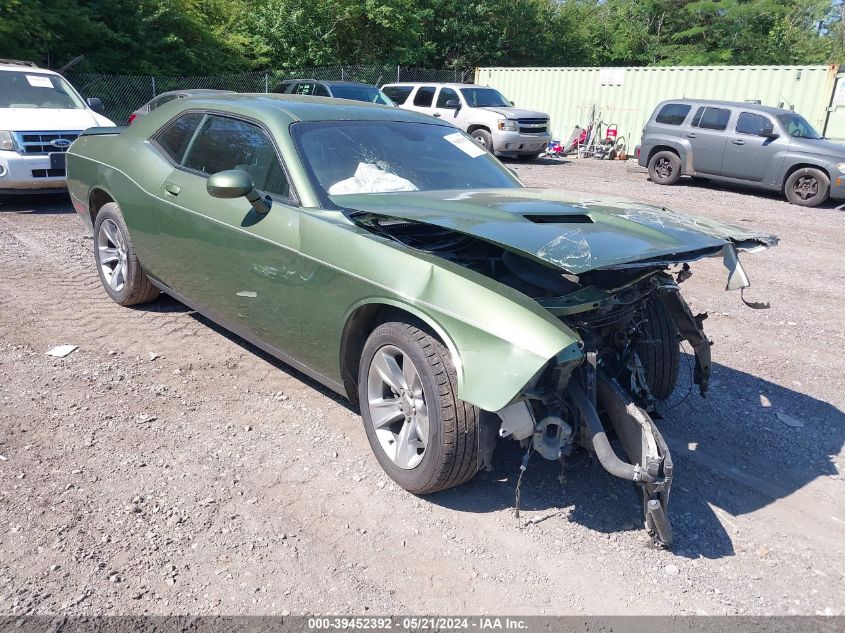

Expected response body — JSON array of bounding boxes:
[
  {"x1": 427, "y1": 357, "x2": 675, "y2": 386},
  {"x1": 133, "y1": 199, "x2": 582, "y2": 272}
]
[{"x1": 358, "y1": 322, "x2": 480, "y2": 494}]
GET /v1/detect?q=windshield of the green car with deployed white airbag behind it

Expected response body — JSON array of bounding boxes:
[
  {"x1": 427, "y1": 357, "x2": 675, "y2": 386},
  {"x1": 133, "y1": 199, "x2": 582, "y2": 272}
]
[{"x1": 291, "y1": 121, "x2": 522, "y2": 199}]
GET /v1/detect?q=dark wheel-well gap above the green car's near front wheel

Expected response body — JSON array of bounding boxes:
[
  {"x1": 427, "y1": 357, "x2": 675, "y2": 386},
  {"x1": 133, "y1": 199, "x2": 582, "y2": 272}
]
[{"x1": 340, "y1": 303, "x2": 445, "y2": 404}]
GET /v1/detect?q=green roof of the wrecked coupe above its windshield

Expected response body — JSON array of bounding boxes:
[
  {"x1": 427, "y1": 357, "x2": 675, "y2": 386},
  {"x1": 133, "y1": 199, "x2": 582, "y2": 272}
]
[{"x1": 171, "y1": 92, "x2": 437, "y2": 123}]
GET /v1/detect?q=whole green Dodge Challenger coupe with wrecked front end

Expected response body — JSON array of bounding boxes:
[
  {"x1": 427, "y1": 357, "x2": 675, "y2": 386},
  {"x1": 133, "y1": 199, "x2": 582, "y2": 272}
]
[{"x1": 67, "y1": 95, "x2": 777, "y2": 545}]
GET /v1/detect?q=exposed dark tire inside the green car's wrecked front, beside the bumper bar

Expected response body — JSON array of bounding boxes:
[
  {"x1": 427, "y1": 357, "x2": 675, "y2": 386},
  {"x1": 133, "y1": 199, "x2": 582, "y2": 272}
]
[{"x1": 636, "y1": 295, "x2": 681, "y2": 400}]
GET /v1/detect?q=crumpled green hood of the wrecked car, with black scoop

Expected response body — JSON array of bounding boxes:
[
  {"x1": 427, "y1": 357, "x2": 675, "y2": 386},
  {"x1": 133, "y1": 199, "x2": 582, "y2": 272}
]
[{"x1": 331, "y1": 188, "x2": 777, "y2": 274}]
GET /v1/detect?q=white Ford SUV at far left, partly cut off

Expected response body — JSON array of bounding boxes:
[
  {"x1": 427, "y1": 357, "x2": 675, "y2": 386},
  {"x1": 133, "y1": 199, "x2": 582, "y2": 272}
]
[{"x1": 0, "y1": 59, "x2": 114, "y2": 194}]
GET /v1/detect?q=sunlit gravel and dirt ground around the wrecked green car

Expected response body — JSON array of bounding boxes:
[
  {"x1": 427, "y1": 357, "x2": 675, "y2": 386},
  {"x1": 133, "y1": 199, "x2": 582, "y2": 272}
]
[{"x1": 0, "y1": 161, "x2": 845, "y2": 614}]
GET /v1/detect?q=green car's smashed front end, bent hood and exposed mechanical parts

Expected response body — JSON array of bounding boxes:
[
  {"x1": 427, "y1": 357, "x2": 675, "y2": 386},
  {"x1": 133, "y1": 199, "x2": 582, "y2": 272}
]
[{"x1": 340, "y1": 189, "x2": 777, "y2": 547}]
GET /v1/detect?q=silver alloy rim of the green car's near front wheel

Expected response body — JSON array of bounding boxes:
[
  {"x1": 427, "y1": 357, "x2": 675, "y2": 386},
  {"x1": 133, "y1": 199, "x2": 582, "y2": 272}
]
[{"x1": 367, "y1": 345, "x2": 429, "y2": 470}]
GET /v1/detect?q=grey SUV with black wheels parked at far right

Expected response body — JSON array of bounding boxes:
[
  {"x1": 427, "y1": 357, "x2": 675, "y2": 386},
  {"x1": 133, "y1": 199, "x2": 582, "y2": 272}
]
[{"x1": 639, "y1": 99, "x2": 845, "y2": 207}]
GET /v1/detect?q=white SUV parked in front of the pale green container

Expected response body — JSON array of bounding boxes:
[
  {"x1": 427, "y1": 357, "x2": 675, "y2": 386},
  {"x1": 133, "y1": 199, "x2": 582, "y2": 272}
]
[{"x1": 382, "y1": 83, "x2": 552, "y2": 159}]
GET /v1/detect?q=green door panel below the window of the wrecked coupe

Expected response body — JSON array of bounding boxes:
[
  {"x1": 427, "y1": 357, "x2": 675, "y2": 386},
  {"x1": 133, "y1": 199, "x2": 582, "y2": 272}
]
[{"x1": 158, "y1": 169, "x2": 301, "y2": 358}]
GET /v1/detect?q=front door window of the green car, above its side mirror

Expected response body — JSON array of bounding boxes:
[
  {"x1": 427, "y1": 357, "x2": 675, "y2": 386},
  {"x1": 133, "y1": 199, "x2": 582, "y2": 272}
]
[{"x1": 182, "y1": 115, "x2": 290, "y2": 197}]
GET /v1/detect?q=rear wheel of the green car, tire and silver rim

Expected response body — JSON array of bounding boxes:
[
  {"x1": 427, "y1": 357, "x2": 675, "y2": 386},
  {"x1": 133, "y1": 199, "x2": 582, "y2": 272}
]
[{"x1": 94, "y1": 202, "x2": 160, "y2": 306}]
